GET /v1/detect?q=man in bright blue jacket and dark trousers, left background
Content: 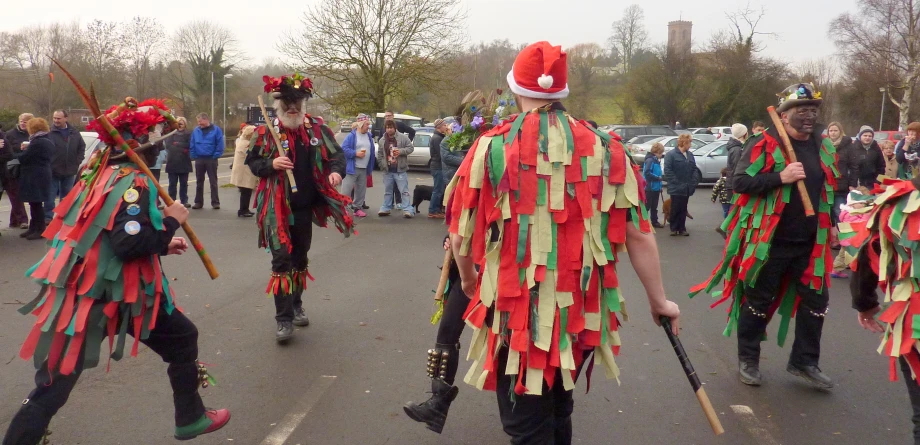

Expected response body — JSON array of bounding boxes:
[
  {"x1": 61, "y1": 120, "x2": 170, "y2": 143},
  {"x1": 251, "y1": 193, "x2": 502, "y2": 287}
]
[{"x1": 189, "y1": 113, "x2": 226, "y2": 210}]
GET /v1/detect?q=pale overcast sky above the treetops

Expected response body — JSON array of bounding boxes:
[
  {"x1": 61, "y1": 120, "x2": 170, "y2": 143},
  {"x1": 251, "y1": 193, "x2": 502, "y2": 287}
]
[{"x1": 0, "y1": 0, "x2": 856, "y2": 67}]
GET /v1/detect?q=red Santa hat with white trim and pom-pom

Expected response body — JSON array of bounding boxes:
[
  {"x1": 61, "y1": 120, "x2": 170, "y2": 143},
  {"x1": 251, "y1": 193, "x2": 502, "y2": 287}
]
[{"x1": 508, "y1": 42, "x2": 569, "y2": 99}]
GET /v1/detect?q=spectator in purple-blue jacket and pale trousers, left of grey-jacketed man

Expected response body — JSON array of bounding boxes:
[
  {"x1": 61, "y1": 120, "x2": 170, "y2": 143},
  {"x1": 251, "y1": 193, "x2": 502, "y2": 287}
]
[{"x1": 342, "y1": 114, "x2": 376, "y2": 218}]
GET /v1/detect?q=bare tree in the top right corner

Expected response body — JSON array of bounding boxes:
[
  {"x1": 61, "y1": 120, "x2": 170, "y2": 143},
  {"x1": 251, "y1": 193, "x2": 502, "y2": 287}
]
[{"x1": 829, "y1": 0, "x2": 920, "y2": 128}]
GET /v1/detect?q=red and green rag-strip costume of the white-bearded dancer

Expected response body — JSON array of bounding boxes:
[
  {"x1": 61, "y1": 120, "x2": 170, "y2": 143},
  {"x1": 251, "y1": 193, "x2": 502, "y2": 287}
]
[{"x1": 249, "y1": 115, "x2": 355, "y2": 294}]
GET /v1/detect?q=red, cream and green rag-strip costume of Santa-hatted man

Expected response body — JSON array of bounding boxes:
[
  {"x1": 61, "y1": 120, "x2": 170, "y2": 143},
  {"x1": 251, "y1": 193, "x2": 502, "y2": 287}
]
[{"x1": 447, "y1": 107, "x2": 651, "y2": 394}]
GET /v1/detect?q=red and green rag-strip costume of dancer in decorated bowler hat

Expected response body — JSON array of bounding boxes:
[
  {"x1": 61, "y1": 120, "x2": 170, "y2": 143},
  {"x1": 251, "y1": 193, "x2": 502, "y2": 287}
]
[{"x1": 690, "y1": 131, "x2": 838, "y2": 346}]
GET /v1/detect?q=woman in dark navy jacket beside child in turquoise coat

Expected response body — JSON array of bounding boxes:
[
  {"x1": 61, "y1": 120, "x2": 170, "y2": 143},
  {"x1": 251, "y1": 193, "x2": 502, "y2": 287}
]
[{"x1": 664, "y1": 134, "x2": 699, "y2": 236}]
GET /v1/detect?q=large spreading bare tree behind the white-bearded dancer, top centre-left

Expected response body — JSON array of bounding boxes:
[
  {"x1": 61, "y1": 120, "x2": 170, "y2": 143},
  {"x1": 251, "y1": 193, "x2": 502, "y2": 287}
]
[{"x1": 278, "y1": 0, "x2": 465, "y2": 111}]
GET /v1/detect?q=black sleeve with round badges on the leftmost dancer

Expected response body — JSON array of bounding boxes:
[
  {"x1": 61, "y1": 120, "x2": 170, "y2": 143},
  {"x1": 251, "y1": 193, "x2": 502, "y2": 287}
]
[{"x1": 109, "y1": 186, "x2": 180, "y2": 261}]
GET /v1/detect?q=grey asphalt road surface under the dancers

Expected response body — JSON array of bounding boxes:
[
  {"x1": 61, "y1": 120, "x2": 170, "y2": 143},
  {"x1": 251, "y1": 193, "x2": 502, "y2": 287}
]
[{"x1": 0, "y1": 160, "x2": 911, "y2": 445}]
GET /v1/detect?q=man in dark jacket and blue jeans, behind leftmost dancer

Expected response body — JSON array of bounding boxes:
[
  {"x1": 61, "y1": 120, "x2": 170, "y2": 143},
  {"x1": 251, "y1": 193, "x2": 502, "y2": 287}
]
[{"x1": 45, "y1": 110, "x2": 86, "y2": 222}]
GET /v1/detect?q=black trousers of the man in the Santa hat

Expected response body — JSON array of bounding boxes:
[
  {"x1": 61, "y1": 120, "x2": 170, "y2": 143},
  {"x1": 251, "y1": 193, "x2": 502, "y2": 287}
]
[{"x1": 495, "y1": 347, "x2": 593, "y2": 445}]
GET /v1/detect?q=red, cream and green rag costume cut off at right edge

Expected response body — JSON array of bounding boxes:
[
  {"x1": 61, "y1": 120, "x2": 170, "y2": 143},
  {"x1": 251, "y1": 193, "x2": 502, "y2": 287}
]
[{"x1": 840, "y1": 179, "x2": 920, "y2": 381}]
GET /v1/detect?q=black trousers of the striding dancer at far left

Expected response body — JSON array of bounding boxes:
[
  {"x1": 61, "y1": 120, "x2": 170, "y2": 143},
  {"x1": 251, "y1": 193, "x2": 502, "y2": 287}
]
[{"x1": 3, "y1": 306, "x2": 205, "y2": 445}]
